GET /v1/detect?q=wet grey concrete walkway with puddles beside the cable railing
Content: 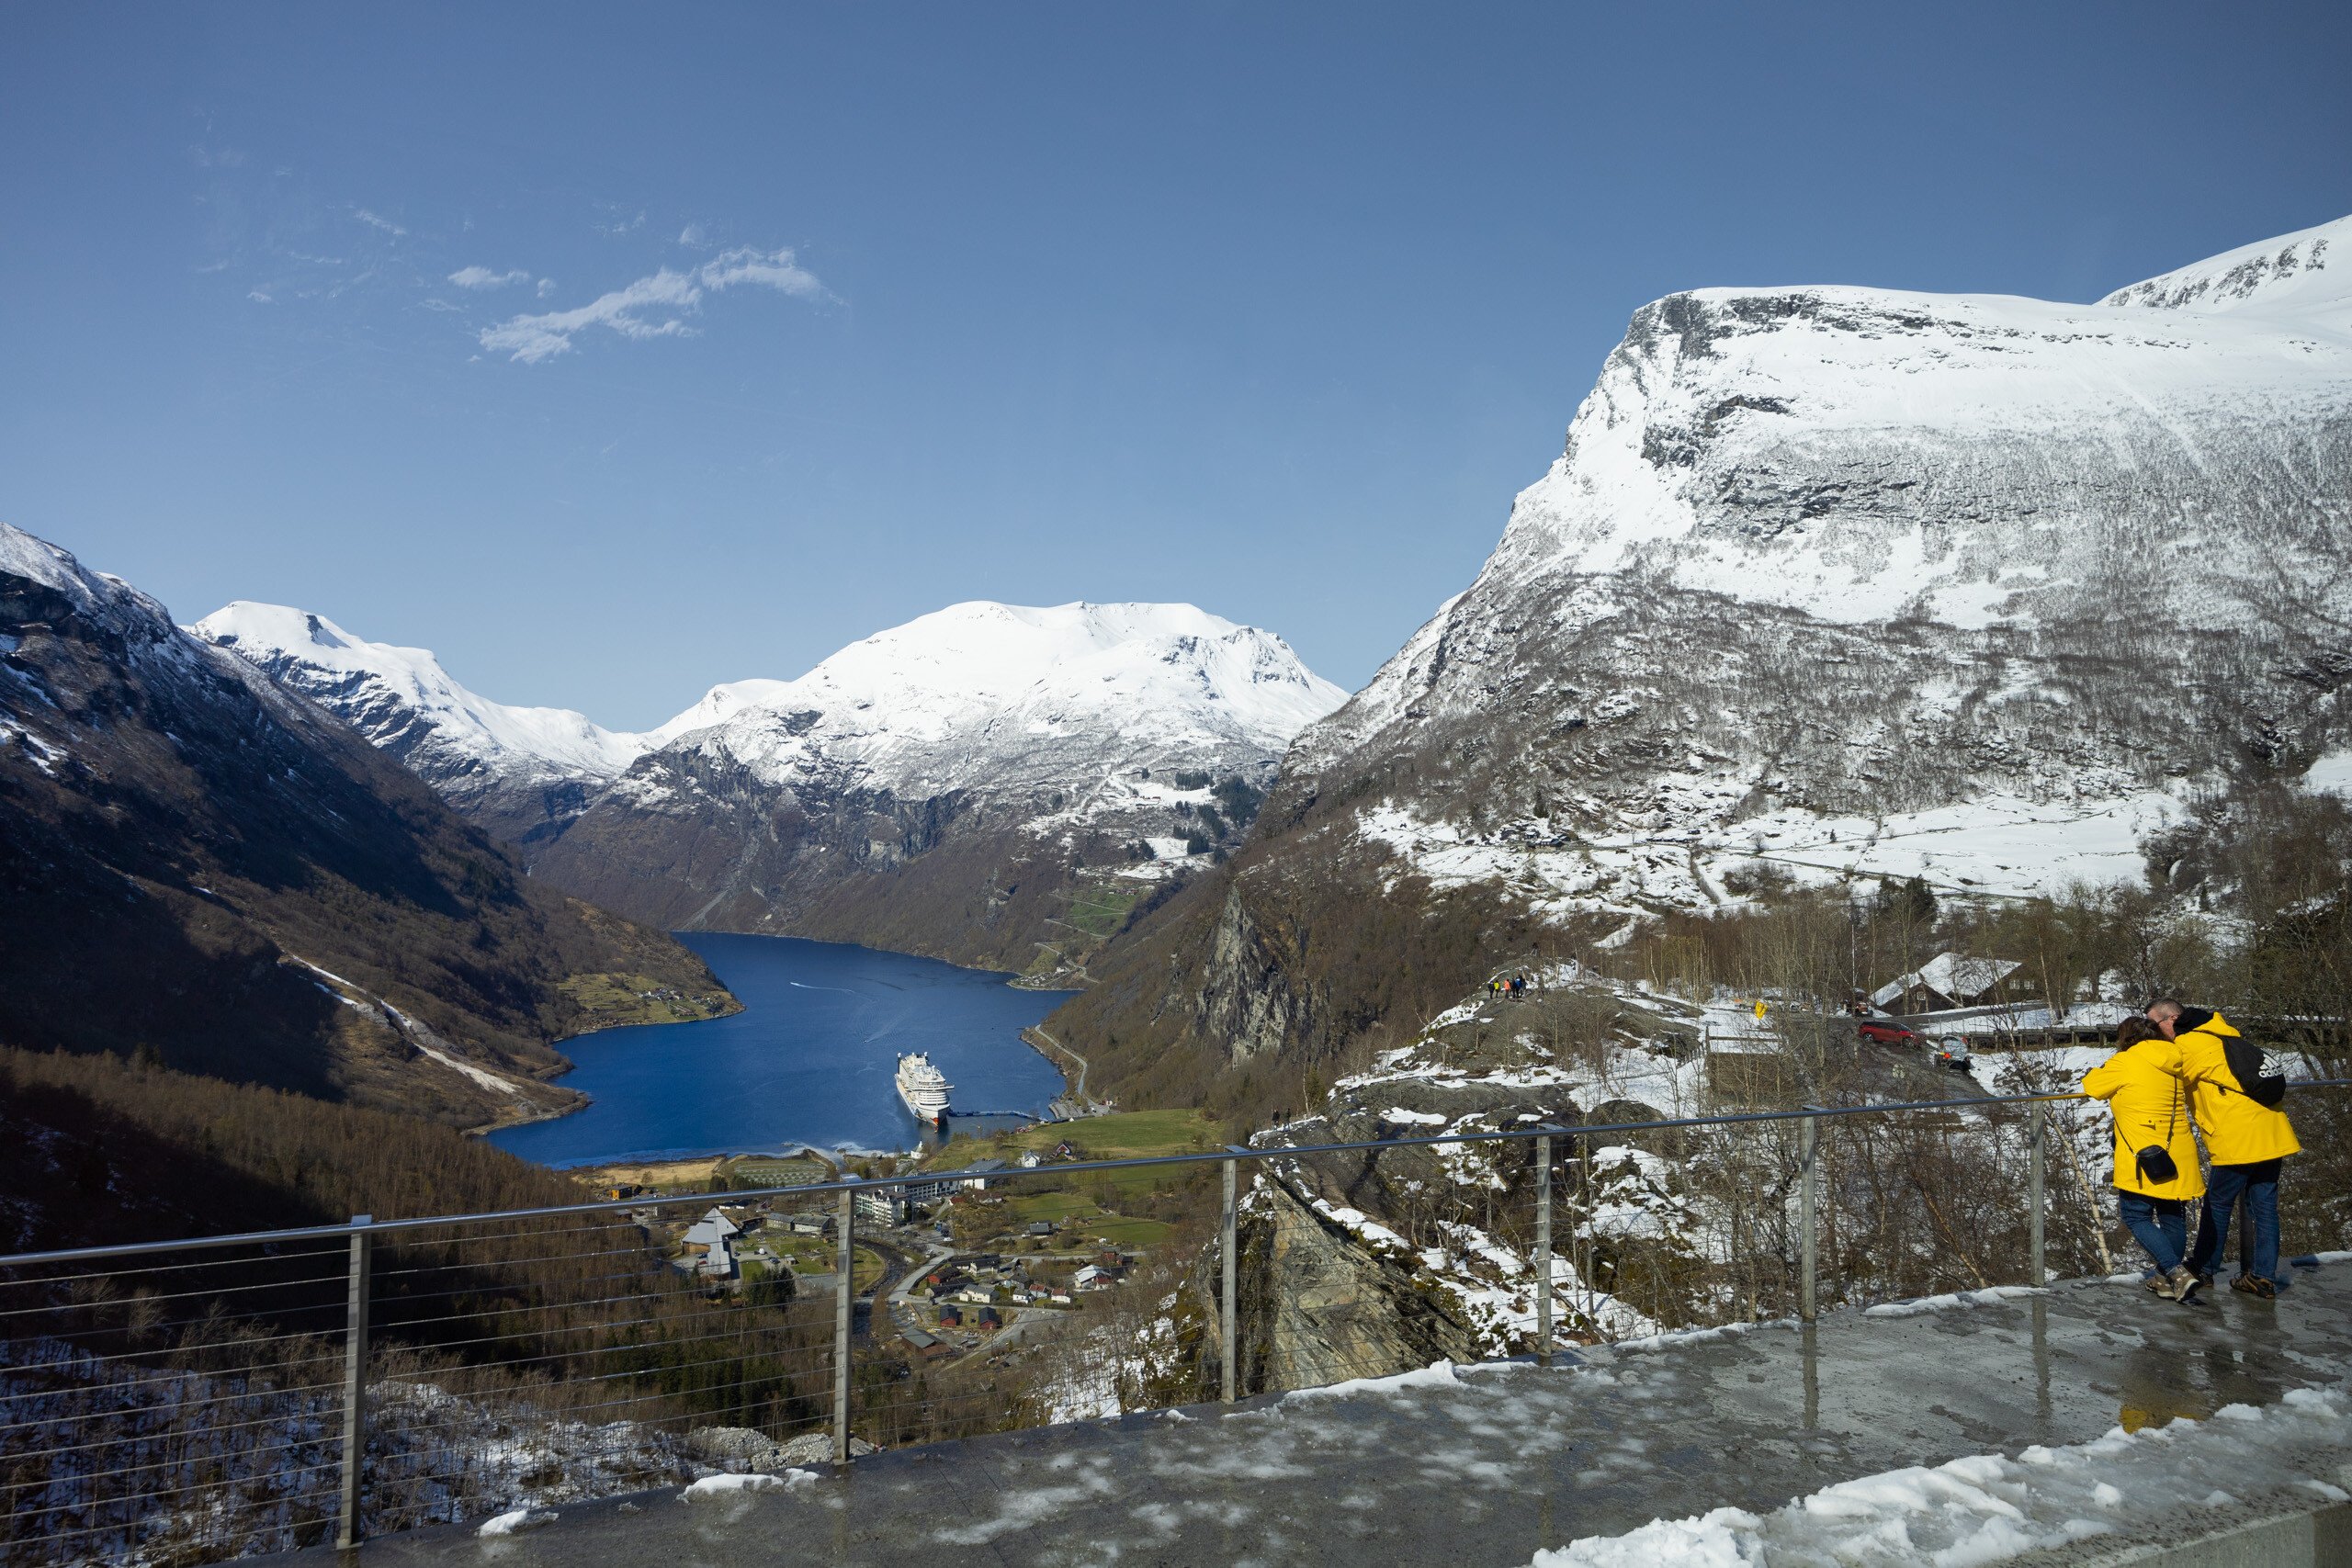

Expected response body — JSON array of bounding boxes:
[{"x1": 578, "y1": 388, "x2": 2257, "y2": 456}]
[{"x1": 326, "y1": 1262, "x2": 2352, "y2": 1568}]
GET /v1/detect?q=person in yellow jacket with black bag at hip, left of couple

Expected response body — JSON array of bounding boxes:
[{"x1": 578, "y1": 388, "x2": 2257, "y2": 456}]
[{"x1": 2082, "y1": 1018, "x2": 2204, "y2": 1303}]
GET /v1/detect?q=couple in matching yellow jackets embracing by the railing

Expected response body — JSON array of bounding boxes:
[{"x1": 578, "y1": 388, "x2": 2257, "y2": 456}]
[{"x1": 2082, "y1": 1001, "x2": 2302, "y2": 1303}]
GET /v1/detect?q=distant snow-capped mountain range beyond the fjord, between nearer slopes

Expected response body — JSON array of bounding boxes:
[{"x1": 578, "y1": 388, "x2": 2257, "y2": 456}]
[{"x1": 211, "y1": 602, "x2": 1345, "y2": 968}]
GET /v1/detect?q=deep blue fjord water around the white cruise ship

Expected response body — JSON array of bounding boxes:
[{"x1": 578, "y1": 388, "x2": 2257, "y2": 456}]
[{"x1": 489, "y1": 931, "x2": 1063, "y2": 1166}]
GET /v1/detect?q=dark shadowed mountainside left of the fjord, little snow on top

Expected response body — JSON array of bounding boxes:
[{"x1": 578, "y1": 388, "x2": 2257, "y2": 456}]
[{"x1": 0, "y1": 525, "x2": 727, "y2": 1123}]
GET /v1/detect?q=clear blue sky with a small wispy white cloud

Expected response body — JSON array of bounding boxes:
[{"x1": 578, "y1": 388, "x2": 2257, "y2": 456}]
[{"x1": 0, "y1": 0, "x2": 2352, "y2": 727}]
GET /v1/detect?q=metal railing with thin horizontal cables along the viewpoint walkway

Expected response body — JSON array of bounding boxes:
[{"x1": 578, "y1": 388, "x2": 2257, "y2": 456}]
[{"x1": 0, "y1": 1079, "x2": 2352, "y2": 1565}]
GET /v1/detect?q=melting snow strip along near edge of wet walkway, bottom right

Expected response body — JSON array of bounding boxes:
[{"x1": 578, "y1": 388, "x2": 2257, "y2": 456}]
[{"x1": 1532, "y1": 1389, "x2": 2352, "y2": 1568}]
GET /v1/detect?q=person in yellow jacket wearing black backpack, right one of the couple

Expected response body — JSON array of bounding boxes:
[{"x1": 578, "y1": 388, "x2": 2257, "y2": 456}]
[{"x1": 2147, "y1": 1001, "x2": 2302, "y2": 1300}]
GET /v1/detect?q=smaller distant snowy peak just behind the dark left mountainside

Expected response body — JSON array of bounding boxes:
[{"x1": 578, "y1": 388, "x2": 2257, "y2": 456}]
[{"x1": 188, "y1": 600, "x2": 647, "y2": 785}]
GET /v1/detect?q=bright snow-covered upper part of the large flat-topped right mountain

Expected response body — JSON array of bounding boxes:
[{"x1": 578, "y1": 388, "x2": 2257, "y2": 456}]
[{"x1": 1430, "y1": 219, "x2": 2352, "y2": 649}]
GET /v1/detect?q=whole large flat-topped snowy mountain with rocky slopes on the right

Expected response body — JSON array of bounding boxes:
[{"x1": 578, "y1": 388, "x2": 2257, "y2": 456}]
[{"x1": 1063, "y1": 219, "x2": 2352, "y2": 1104}]
